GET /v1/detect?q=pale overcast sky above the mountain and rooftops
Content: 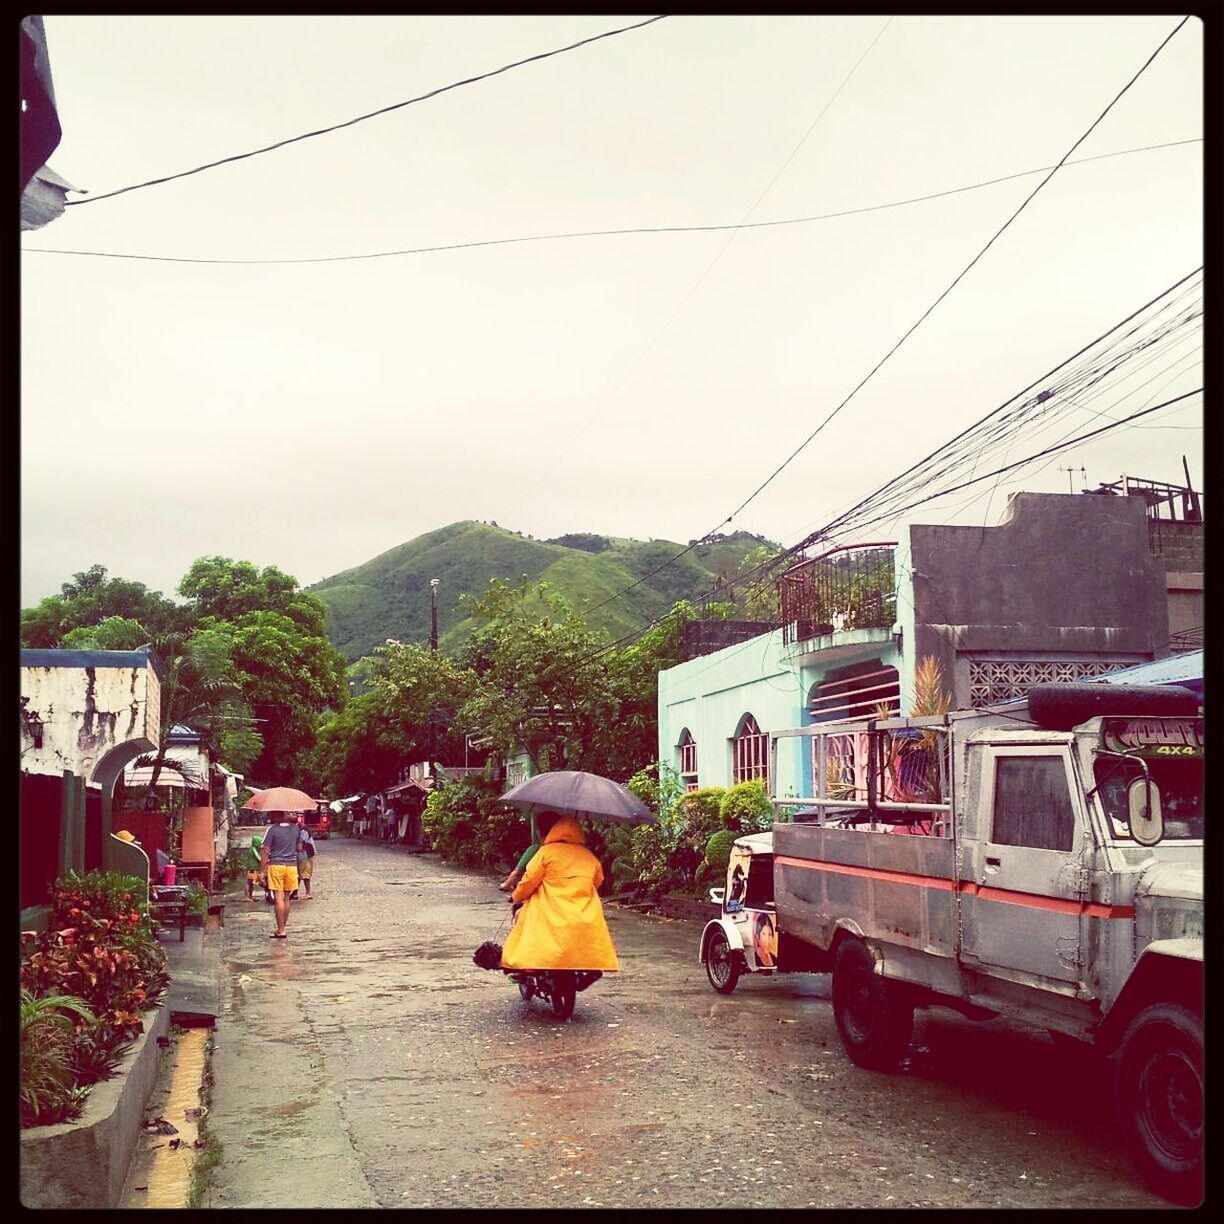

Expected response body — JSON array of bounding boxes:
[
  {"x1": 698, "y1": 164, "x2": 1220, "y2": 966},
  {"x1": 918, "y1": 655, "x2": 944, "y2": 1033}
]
[{"x1": 20, "y1": 13, "x2": 1203, "y2": 606}]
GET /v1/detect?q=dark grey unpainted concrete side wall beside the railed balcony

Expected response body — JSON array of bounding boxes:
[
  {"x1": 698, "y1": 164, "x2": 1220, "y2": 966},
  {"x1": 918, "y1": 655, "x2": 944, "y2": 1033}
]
[{"x1": 905, "y1": 493, "x2": 1169, "y2": 705}]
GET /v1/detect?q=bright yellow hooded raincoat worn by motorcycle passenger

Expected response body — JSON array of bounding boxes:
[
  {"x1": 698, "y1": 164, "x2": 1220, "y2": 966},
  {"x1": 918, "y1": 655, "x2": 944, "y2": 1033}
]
[{"x1": 502, "y1": 815, "x2": 621, "y2": 972}]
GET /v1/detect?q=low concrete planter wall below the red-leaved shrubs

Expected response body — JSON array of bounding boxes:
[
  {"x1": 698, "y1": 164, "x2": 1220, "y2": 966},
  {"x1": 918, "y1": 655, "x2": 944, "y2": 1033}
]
[{"x1": 21, "y1": 1006, "x2": 170, "y2": 1209}]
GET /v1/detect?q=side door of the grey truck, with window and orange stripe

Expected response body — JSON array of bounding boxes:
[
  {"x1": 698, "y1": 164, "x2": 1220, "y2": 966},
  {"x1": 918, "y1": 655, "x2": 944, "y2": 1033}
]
[{"x1": 961, "y1": 744, "x2": 1086, "y2": 987}]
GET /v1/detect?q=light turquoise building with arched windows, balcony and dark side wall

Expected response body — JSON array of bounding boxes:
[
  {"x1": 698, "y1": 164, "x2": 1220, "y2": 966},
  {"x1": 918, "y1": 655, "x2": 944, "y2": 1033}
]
[{"x1": 659, "y1": 493, "x2": 1202, "y2": 796}]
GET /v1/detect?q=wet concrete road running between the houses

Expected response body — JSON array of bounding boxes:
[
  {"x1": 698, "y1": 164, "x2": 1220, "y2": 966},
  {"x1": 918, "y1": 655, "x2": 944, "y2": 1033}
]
[{"x1": 207, "y1": 840, "x2": 1166, "y2": 1208}]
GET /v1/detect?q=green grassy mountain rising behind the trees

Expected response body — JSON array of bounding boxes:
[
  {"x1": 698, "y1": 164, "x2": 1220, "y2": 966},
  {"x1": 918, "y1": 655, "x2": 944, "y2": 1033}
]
[{"x1": 308, "y1": 521, "x2": 776, "y2": 661}]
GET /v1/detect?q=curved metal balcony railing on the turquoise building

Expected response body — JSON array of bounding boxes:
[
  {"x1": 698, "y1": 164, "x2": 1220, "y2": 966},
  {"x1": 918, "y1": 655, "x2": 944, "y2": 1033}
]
[{"x1": 777, "y1": 540, "x2": 897, "y2": 645}]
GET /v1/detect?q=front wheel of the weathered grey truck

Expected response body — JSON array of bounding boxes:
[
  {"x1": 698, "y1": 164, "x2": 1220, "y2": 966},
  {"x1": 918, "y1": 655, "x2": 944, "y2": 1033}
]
[{"x1": 1116, "y1": 1004, "x2": 1203, "y2": 1207}]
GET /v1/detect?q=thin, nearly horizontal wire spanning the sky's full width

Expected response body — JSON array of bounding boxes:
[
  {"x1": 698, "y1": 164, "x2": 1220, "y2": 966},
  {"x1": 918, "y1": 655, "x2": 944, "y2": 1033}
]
[{"x1": 24, "y1": 137, "x2": 1202, "y2": 267}]
